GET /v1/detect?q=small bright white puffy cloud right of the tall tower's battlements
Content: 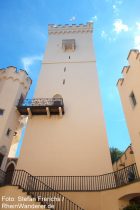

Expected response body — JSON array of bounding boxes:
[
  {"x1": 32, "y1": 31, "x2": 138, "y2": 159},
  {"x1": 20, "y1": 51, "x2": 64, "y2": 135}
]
[{"x1": 113, "y1": 19, "x2": 129, "y2": 33}]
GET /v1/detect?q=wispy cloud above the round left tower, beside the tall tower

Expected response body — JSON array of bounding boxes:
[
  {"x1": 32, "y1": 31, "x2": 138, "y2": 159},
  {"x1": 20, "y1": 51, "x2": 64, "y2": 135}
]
[{"x1": 21, "y1": 55, "x2": 43, "y2": 73}]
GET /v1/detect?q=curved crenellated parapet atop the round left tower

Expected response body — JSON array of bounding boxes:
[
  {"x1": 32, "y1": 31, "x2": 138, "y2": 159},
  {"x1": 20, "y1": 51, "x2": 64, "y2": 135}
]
[{"x1": 0, "y1": 66, "x2": 32, "y2": 89}]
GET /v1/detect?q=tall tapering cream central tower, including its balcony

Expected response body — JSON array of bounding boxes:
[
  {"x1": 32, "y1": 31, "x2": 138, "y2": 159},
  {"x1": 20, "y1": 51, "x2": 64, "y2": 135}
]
[{"x1": 18, "y1": 23, "x2": 112, "y2": 176}]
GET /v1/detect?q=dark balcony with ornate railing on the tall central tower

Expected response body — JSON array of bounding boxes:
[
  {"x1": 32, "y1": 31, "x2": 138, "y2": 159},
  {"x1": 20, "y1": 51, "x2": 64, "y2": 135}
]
[{"x1": 17, "y1": 98, "x2": 64, "y2": 116}]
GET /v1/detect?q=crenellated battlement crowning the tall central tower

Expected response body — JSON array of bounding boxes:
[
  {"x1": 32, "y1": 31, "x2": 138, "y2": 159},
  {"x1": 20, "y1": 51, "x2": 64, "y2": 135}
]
[{"x1": 48, "y1": 22, "x2": 93, "y2": 34}]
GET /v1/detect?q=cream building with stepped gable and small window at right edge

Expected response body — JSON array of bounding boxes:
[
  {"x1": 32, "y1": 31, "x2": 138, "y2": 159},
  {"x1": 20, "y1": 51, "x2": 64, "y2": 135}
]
[{"x1": 117, "y1": 50, "x2": 140, "y2": 174}]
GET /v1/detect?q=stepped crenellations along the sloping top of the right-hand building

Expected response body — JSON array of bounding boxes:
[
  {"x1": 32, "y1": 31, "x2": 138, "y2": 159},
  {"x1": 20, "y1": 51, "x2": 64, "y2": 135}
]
[{"x1": 117, "y1": 49, "x2": 140, "y2": 87}]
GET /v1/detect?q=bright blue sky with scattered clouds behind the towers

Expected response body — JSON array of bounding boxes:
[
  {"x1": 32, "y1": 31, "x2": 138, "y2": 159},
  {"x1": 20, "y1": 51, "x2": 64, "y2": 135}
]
[{"x1": 0, "y1": 0, "x2": 140, "y2": 150}]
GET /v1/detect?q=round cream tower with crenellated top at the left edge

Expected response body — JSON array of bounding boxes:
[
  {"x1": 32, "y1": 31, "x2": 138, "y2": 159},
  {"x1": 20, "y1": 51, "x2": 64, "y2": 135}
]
[{"x1": 0, "y1": 66, "x2": 31, "y2": 170}]
